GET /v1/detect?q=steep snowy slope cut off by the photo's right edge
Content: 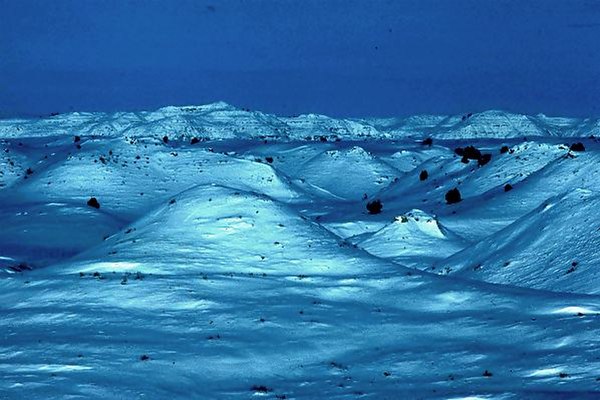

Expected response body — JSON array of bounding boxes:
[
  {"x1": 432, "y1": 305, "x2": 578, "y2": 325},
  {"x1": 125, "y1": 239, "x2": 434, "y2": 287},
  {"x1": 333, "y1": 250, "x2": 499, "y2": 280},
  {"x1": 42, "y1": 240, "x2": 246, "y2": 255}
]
[{"x1": 435, "y1": 189, "x2": 600, "y2": 294}]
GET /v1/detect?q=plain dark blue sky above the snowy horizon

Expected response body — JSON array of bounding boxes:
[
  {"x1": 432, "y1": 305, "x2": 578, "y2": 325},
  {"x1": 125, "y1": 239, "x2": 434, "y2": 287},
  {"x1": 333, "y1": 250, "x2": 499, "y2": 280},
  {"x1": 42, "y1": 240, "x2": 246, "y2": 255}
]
[{"x1": 0, "y1": 0, "x2": 600, "y2": 116}]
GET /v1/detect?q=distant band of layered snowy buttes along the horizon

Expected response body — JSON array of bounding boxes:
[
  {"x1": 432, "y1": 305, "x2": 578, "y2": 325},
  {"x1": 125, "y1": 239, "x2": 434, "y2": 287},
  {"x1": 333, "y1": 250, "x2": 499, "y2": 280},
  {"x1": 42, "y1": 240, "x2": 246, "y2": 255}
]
[{"x1": 0, "y1": 102, "x2": 600, "y2": 140}]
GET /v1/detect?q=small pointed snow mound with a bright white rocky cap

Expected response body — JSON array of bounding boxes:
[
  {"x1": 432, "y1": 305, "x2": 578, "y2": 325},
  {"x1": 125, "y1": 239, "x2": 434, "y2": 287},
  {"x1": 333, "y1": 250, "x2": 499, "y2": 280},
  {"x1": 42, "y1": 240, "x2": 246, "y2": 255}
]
[{"x1": 353, "y1": 210, "x2": 466, "y2": 269}]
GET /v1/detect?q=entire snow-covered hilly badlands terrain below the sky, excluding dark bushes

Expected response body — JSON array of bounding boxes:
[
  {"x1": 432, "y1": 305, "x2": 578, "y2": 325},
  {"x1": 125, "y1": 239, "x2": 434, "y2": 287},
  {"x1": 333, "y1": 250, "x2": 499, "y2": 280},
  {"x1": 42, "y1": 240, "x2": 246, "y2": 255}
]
[{"x1": 0, "y1": 103, "x2": 600, "y2": 399}]
